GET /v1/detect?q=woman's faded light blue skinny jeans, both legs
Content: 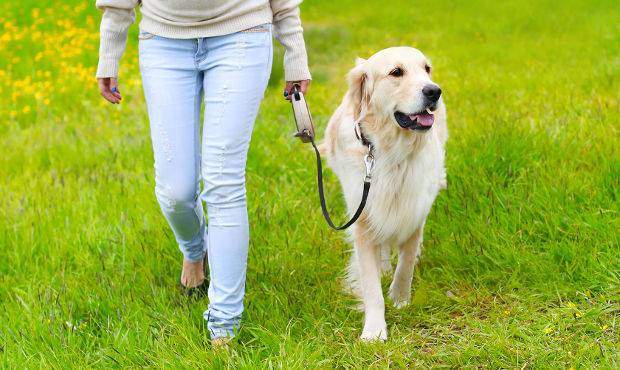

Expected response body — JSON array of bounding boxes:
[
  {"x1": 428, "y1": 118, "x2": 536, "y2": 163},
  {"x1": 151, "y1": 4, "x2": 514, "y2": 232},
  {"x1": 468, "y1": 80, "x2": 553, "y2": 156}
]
[{"x1": 139, "y1": 24, "x2": 273, "y2": 338}]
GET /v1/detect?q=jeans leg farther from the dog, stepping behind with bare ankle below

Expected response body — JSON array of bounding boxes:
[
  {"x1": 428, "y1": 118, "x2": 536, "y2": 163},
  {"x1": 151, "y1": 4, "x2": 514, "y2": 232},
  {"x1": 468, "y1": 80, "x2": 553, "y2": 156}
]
[{"x1": 140, "y1": 36, "x2": 205, "y2": 262}]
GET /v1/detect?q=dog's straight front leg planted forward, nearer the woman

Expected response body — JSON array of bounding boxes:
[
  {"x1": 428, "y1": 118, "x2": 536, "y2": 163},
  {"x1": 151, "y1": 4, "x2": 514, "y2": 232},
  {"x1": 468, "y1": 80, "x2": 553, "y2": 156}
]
[{"x1": 355, "y1": 228, "x2": 387, "y2": 341}]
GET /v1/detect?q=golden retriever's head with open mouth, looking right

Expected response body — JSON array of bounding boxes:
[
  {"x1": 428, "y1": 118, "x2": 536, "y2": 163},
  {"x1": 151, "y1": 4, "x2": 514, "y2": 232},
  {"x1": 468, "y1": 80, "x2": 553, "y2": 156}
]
[{"x1": 348, "y1": 47, "x2": 441, "y2": 132}]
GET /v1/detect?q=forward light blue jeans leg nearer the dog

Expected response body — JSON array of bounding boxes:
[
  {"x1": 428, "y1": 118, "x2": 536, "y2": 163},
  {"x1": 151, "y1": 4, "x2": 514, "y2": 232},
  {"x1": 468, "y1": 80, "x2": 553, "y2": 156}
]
[{"x1": 197, "y1": 25, "x2": 272, "y2": 338}]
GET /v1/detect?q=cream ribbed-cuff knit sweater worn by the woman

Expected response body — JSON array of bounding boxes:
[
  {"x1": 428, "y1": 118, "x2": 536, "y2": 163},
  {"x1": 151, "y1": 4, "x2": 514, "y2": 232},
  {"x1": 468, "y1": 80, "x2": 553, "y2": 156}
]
[{"x1": 96, "y1": 0, "x2": 310, "y2": 81}]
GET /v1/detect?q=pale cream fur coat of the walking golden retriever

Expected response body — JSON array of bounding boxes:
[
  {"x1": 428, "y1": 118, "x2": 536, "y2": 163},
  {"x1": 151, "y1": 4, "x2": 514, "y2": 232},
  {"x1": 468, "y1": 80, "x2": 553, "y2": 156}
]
[{"x1": 321, "y1": 47, "x2": 448, "y2": 340}]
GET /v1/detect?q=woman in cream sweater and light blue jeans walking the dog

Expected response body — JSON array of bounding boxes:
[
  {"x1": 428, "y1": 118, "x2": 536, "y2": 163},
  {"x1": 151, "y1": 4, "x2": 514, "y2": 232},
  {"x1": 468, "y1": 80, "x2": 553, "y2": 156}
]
[{"x1": 96, "y1": 0, "x2": 310, "y2": 344}]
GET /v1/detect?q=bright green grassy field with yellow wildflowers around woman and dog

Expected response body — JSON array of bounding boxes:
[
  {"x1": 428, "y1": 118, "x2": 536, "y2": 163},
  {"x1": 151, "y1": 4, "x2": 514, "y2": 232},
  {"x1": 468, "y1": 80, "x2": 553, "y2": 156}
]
[{"x1": 0, "y1": 0, "x2": 620, "y2": 368}]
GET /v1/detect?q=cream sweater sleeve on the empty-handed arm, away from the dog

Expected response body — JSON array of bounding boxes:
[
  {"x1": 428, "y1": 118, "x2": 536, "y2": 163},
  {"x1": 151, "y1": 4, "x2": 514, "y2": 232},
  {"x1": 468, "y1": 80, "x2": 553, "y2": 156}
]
[{"x1": 96, "y1": 0, "x2": 138, "y2": 78}]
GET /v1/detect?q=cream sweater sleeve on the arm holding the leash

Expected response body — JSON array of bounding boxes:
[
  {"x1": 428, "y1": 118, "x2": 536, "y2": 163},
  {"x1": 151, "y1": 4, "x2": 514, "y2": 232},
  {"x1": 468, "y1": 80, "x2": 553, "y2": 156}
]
[{"x1": 270, "y1": 0, "x2": 311, "y2": 81}]
